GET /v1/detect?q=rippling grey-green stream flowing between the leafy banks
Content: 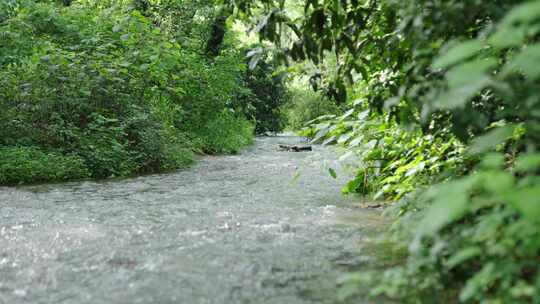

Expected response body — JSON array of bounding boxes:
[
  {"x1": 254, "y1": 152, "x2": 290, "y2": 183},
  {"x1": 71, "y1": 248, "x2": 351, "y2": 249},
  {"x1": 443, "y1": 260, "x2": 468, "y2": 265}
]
[{"x1": 0, "y1": 137, "x2": 388, "y2": 304}]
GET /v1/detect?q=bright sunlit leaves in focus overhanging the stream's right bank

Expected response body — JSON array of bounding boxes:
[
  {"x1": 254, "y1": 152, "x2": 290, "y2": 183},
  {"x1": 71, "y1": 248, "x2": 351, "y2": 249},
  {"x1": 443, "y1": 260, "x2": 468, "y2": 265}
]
[{"x1": 307, "y1": 103, "x2": 465, "y2": 200}]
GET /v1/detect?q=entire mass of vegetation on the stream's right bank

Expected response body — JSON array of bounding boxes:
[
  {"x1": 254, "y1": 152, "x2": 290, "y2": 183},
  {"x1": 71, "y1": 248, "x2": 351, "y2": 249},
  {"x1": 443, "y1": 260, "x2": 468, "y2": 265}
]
[{"x1": 235, "y1": 0, "x2": 540, "y2": 303}]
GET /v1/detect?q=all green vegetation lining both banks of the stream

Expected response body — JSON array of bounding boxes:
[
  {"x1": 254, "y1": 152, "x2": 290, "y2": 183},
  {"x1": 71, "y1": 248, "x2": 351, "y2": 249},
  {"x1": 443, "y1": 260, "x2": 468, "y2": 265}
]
[{"x1": 0, "y1": 0, "x2": 540, "y2": 303}]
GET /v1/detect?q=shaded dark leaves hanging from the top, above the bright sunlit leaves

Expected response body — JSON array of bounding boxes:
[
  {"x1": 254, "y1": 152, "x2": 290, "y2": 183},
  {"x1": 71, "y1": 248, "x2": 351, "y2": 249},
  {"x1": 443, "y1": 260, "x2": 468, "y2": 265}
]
[{"x1": 235, "y1": 0, "x2": 520, "y2": 127}]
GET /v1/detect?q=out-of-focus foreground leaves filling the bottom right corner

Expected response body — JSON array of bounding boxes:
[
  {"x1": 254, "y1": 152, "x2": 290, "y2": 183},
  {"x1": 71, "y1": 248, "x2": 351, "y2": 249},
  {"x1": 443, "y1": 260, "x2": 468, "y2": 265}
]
[{"x1": 350, "y1": 153, "x2": 540, "y2": 303}]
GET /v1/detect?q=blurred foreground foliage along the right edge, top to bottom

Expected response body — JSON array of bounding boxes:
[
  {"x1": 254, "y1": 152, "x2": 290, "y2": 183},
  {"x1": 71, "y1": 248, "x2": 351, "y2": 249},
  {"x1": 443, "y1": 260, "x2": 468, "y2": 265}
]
[{"x1": 330, "y1": 1, "x2": 540, "y2": 303}]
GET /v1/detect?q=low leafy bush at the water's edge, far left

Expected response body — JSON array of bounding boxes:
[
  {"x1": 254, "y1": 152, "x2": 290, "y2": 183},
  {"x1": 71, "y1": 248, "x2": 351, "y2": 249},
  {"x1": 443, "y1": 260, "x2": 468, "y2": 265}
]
[{"x1": 0, "y1": 146, "x2": 90, "y2": 184}]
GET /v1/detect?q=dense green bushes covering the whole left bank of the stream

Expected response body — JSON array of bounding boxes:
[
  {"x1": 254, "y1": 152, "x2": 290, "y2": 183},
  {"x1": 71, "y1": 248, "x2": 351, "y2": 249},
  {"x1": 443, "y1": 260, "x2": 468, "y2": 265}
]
[{"x1": 0, "y1": 0, "x2": 287, "y2": 184}]
